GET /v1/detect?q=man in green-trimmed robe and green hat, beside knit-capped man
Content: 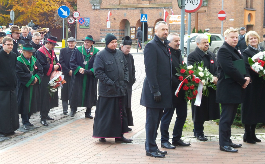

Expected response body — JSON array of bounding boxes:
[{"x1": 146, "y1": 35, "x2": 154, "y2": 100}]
[{"x1": 69, "y1": 35, "x2": 99, "y2": 119}]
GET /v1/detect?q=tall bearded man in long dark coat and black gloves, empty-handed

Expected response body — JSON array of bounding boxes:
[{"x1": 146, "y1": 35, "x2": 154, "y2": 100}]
[{"x1": 140, "y1": 21, "x2": 172, "y2": 158}]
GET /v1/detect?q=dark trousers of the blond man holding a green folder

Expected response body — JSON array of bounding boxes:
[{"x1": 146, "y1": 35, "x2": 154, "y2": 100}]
[{"x1": 219, "y1": 104, "x2": 239, "y2": 146}]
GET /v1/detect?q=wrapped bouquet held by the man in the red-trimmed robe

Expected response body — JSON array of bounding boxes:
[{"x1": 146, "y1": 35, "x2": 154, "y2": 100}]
[{"x1": 48, "y1": 71, "x2": 66, "y2": 96}]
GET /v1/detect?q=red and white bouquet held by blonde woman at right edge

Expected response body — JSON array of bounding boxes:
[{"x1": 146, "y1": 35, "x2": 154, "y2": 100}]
[{"x1": 248, "y1": 52, "x2": 265, "y2": 80}]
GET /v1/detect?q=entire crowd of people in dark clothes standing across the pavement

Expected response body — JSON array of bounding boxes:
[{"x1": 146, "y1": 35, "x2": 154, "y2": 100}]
[{"x1": 0, "y1": 21, "x2": 265, "y2": 158}]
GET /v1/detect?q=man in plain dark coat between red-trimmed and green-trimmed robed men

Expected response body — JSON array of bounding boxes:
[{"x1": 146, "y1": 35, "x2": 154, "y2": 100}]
[{"x1": 59, "y1": 37, "x2": 76, "y2": 115}]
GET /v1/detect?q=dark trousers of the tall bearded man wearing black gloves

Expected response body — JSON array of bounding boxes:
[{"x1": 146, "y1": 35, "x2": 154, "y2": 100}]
[{"x1": 145, "y1": 107, "x2": 163, "y2": 152}]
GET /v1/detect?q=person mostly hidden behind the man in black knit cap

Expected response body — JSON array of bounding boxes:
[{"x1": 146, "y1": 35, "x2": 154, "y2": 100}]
[{"x1": 120, "y1": 36, "x2": 136, "y2": 131}]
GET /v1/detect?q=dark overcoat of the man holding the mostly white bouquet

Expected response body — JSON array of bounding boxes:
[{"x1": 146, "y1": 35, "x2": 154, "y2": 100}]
[{"x1": 188, "y1": 47, "x2": 220, "y2": 122}]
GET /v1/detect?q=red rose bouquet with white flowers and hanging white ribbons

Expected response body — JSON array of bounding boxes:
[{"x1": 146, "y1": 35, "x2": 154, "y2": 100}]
[{"x1": 175, "y1": 63, "x2": 203, "y2": 106}]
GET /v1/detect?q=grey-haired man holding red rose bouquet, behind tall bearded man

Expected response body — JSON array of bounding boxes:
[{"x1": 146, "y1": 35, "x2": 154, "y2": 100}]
[{"x1": 160, "y1": 33, "x2": 190, "y2": 149}]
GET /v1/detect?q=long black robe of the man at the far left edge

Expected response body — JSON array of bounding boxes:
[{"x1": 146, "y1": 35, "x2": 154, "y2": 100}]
[{"x1": 0, "y1": 49, "x2": 19, "y2": 133}]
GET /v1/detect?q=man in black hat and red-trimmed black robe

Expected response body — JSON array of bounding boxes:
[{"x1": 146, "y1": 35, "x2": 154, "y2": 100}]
[{"x1": 36, "y1": 36, "x2": 61, "y2": 126}]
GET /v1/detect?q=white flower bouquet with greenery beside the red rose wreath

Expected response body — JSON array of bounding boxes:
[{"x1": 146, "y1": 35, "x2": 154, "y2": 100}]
[{"x1": 194, "y1": 62, "x2": 216, "y2": 96}]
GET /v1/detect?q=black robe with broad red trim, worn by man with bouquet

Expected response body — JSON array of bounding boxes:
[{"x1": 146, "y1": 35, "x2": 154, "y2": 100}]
[{"x1": 36, "y1": 46, "x2": 61, "y2": 119}]
